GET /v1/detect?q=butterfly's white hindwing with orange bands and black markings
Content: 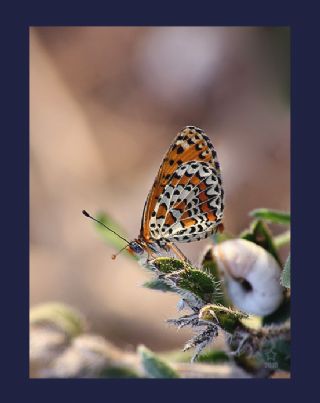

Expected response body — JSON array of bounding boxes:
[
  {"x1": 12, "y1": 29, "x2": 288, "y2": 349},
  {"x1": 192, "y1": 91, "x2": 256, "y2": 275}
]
[{"x1": 150, "y1": 162, "x2": 223, "y2": 242}]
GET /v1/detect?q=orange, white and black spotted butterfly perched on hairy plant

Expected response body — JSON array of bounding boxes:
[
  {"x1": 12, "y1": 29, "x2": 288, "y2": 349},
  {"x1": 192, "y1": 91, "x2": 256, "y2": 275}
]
[{"x1": 83, "y1": 126, "x2": 224, "y2": 259}]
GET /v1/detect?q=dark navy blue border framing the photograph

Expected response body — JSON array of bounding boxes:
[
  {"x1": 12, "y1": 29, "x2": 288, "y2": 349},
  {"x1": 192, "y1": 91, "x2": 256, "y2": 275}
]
[{"x1": 0, "y1": 0, "x2": 320, "y2": 403}]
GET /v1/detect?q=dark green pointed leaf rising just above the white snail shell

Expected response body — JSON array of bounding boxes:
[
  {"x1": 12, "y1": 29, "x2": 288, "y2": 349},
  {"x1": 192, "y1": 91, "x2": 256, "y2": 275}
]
[{"x1": 240, "y1": 220, "x2": 282, "y2": 266}]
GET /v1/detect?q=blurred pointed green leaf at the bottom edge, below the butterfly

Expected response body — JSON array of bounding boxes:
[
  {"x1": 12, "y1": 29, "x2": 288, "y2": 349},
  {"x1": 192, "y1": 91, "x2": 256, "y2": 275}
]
[{"x1": 138, "y1": 345, "x2": 179, "y2": 378}]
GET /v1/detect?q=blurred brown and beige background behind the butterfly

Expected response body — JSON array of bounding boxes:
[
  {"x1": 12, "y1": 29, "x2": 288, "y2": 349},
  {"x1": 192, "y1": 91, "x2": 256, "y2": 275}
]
[{"x1": 30, "y1": 27, "x2": 290, "y2": 351}]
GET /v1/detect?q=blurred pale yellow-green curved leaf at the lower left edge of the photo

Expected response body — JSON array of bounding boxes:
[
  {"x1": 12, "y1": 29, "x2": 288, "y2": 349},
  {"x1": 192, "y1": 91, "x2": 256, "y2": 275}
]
[{"x1": 30, "y1": 302, "x2": 87, "y2": 337}]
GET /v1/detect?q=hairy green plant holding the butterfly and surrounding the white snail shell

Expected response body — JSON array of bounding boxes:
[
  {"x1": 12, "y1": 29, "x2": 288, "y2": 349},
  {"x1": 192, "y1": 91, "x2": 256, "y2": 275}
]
[{"x1": 94, "y1": 209, "x2": 290, "y2": 376}]
